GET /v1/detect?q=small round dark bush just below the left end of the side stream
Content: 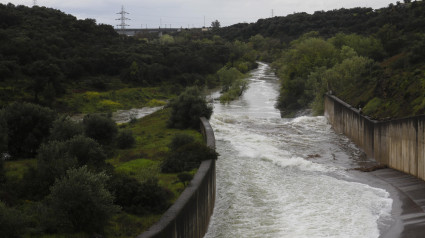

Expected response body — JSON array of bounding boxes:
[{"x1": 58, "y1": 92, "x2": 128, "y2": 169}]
[{"x1": 83, "y1": 114, "x2": 118, "y2": 145}]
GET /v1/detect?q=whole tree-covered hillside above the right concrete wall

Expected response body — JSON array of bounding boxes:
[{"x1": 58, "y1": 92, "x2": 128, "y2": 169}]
[{"x1": 220, "y1": 0, "x2": 425, "y2": 119}]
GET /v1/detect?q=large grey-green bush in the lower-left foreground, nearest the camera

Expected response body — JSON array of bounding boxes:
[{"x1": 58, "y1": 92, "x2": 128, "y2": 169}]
[{"x1": 46, "y1": 166, "x2": 119, "y2": 234}]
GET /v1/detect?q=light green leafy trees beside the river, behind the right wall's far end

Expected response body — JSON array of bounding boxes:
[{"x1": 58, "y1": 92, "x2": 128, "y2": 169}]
[{"x1": 274, "y1": 32, "x2": 376, "y2": 116}]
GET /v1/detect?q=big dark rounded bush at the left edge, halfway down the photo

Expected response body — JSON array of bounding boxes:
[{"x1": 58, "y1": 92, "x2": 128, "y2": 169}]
[{"x1": 3, "y1": 102, "x2": 56, "y2": 158}]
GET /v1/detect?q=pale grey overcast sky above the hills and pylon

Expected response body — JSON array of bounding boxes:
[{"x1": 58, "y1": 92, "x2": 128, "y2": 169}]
[{"x1": 0, "y1": 0, "x2": 402, "y2": 28}]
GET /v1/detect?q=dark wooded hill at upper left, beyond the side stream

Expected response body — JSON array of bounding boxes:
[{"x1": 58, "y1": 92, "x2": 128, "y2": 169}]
[{"x1": 0, "y1": 4, "x2": 238, "y2": 111}]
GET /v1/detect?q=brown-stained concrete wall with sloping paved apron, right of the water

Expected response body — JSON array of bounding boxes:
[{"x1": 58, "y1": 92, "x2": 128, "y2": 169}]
[{"x1": 325, "y1": 95, "x2": 425, "y2": 238}]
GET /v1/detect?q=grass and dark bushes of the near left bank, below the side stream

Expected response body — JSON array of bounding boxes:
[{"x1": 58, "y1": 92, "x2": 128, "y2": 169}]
[{"x1": 0, "y1": 103, "x2": 209, "y2": 237}]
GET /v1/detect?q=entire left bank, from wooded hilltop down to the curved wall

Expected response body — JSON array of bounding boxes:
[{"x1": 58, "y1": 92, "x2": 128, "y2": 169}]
[{"x1": 0, "y1": 4, "x2": 256, "y2": 237}]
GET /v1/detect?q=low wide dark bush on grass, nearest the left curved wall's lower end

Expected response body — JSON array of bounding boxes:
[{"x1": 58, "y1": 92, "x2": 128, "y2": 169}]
[{"x1": 109, "y1": 174, "x2": 172, "y2": 215}]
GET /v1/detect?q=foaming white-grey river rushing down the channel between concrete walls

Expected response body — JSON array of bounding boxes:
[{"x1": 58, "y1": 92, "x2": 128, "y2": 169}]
[{"x1": 205, "y1": 63, "x2": 393, "y2": 238}]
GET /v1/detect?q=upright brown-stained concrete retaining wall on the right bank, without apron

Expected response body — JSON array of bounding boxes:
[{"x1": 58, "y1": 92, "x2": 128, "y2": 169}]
[{"x1": 325, "y1": 95, "x2": 425, "y2": 180}]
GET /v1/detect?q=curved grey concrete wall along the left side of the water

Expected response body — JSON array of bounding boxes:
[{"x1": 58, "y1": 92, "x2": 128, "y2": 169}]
[{"x1": 138, "y1": 118, "x2": 216, "y2": 238}]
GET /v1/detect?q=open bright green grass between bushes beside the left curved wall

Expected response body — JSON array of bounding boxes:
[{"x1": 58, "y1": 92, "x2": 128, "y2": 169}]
[{"x1": 5, "y1": 108, "x2": 203, "y2": 237}]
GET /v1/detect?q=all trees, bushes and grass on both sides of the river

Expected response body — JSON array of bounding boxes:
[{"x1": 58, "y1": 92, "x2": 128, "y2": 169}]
[{"x1": 0, "y1": 0, "x2": 425, "y2": 237}]
